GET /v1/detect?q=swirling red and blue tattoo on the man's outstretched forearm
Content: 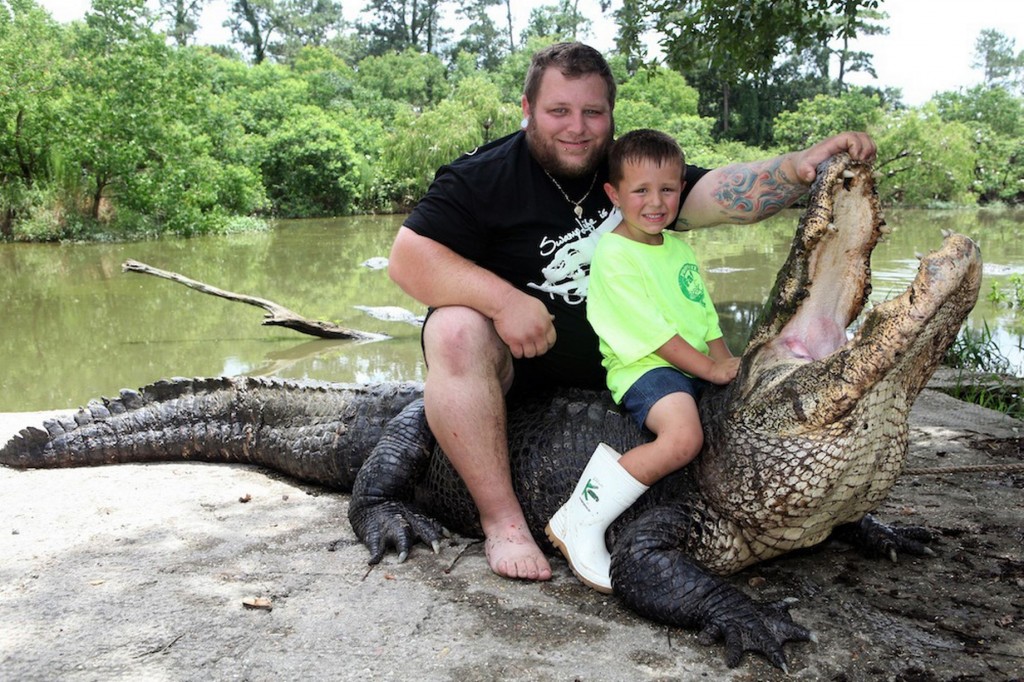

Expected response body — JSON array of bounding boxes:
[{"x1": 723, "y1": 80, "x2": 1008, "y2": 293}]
[{"x1": 714, "y1": 157, "x2": 807, "y2": 223}]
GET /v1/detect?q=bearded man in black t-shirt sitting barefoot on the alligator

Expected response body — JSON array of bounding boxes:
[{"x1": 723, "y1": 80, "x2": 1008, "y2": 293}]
[{"x1": 388, "y1": 43, "x2": 874, "y2": 581}]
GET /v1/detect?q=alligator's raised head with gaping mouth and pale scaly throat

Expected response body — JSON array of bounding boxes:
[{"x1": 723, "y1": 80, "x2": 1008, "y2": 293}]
[{"x1": 697, "y1": 155, "x2": 981, "y2": 572}]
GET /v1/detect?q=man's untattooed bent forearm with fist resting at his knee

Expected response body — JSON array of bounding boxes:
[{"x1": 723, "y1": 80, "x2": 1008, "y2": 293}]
[{"x1": 388, "y1": 226, "x2": 555, "y2": 357}]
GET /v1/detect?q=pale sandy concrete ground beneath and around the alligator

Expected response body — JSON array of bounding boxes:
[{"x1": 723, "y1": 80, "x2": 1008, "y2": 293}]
[{"x1": 0, "y1": 390, "x2": 1024, "y2": 682}]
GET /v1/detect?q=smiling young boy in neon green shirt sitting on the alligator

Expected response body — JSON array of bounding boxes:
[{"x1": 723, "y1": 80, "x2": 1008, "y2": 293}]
[{"x1": 546, "y1": 130, "x2": 739, "y2": 593}]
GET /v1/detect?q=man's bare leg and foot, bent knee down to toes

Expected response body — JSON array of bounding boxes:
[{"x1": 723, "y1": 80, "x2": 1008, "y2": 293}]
[{"x1": 423, "y1": 307, "x2": 551, "y2": 581}]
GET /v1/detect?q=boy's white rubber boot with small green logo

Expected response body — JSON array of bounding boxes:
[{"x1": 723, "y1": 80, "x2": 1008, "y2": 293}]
[{"x1": 545, "y1": 442, "x2": 647, "y2": 594}]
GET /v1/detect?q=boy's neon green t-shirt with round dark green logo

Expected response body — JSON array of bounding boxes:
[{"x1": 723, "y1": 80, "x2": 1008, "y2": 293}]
[{"x1": 587, "y1": 231, "x2": 722, "y2": 402}]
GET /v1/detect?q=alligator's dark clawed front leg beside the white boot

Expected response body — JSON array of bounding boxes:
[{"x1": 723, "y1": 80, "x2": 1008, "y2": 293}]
[{"x1": 611, "y1": 505, "x2": 813, "y2": 670}]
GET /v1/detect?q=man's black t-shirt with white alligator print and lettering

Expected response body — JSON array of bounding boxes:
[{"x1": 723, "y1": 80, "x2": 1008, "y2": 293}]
[{"x1": 404, "y1": 132, "x2": 708, "y2": 388}]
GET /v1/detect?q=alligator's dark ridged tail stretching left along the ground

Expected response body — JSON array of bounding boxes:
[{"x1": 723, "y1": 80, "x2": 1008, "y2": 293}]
[{"x1": 0, "y1": 377, "x2": 422, "y2": 491}]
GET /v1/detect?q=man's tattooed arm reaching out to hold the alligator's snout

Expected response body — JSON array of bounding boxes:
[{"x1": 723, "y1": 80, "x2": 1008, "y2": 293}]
[{"x1": 679, "y1": 132, "x2": 876, "y2": 229}]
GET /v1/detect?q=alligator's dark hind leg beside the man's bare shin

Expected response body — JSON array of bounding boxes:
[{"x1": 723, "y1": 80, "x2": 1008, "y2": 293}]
[{"x1": 348, "y1": 399, "x2": 443, "y2": 564}]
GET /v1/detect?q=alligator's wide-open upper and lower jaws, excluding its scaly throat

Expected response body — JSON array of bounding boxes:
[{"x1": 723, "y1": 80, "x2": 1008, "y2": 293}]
[{"x1": 736, "y1": 155, "x2": 981, "y2": 419}]
